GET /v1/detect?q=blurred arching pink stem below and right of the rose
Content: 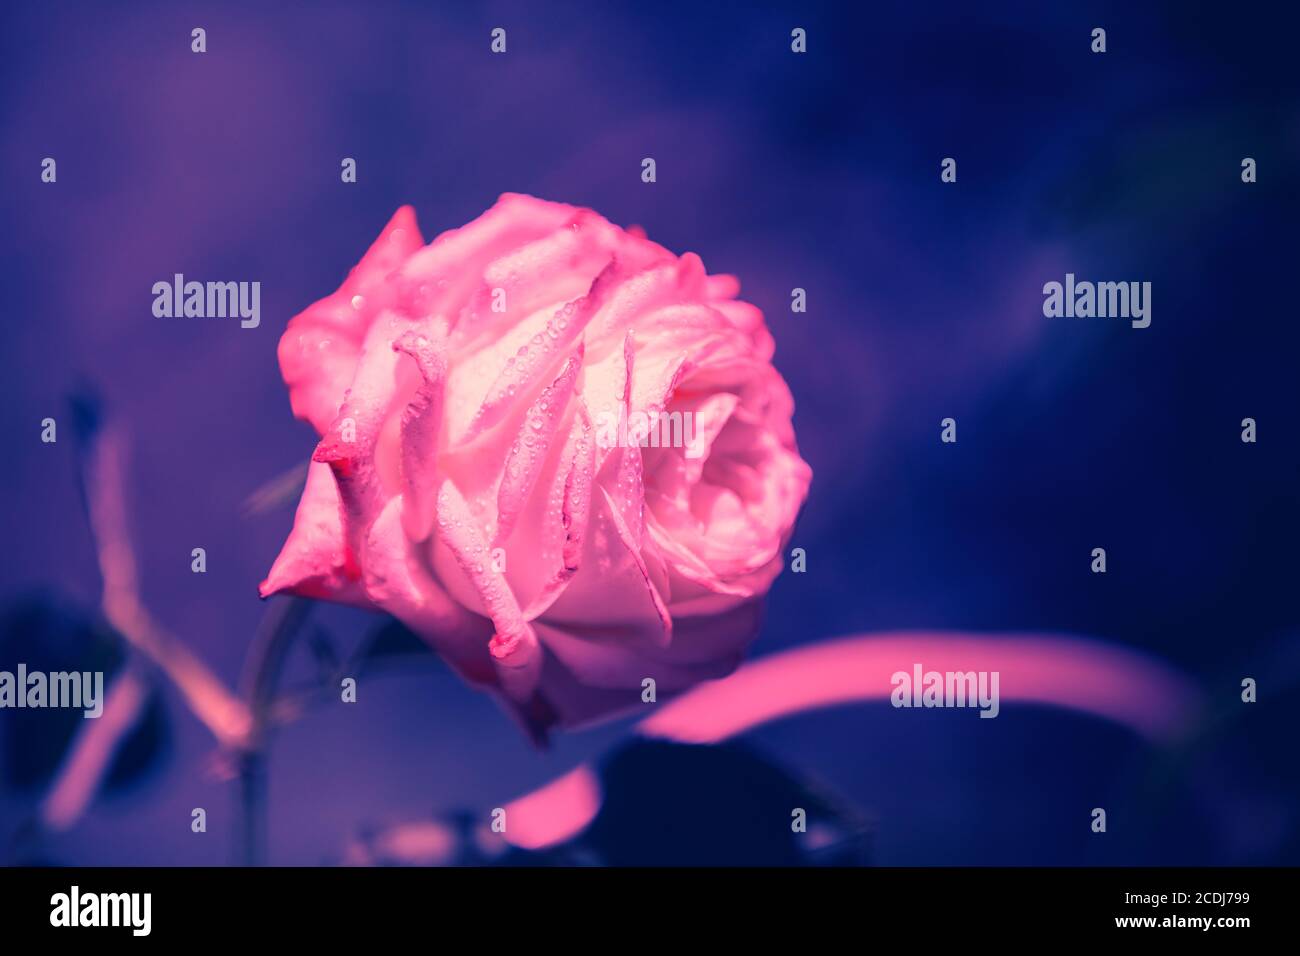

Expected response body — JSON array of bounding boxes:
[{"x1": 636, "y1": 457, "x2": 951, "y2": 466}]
[{"x1": 506, "y1": 631, "x2": 1200, "y2": 849}]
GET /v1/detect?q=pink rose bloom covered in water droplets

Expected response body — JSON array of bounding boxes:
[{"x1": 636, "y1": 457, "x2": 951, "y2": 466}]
[{"x1": 261, "y1": 194, "x2": 811, "y2": 734}]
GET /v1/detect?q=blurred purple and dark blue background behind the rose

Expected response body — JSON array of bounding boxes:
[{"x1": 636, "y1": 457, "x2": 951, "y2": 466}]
[{"x1": 0, "y1": 0, "x2": 1300, "y2": 865}]
